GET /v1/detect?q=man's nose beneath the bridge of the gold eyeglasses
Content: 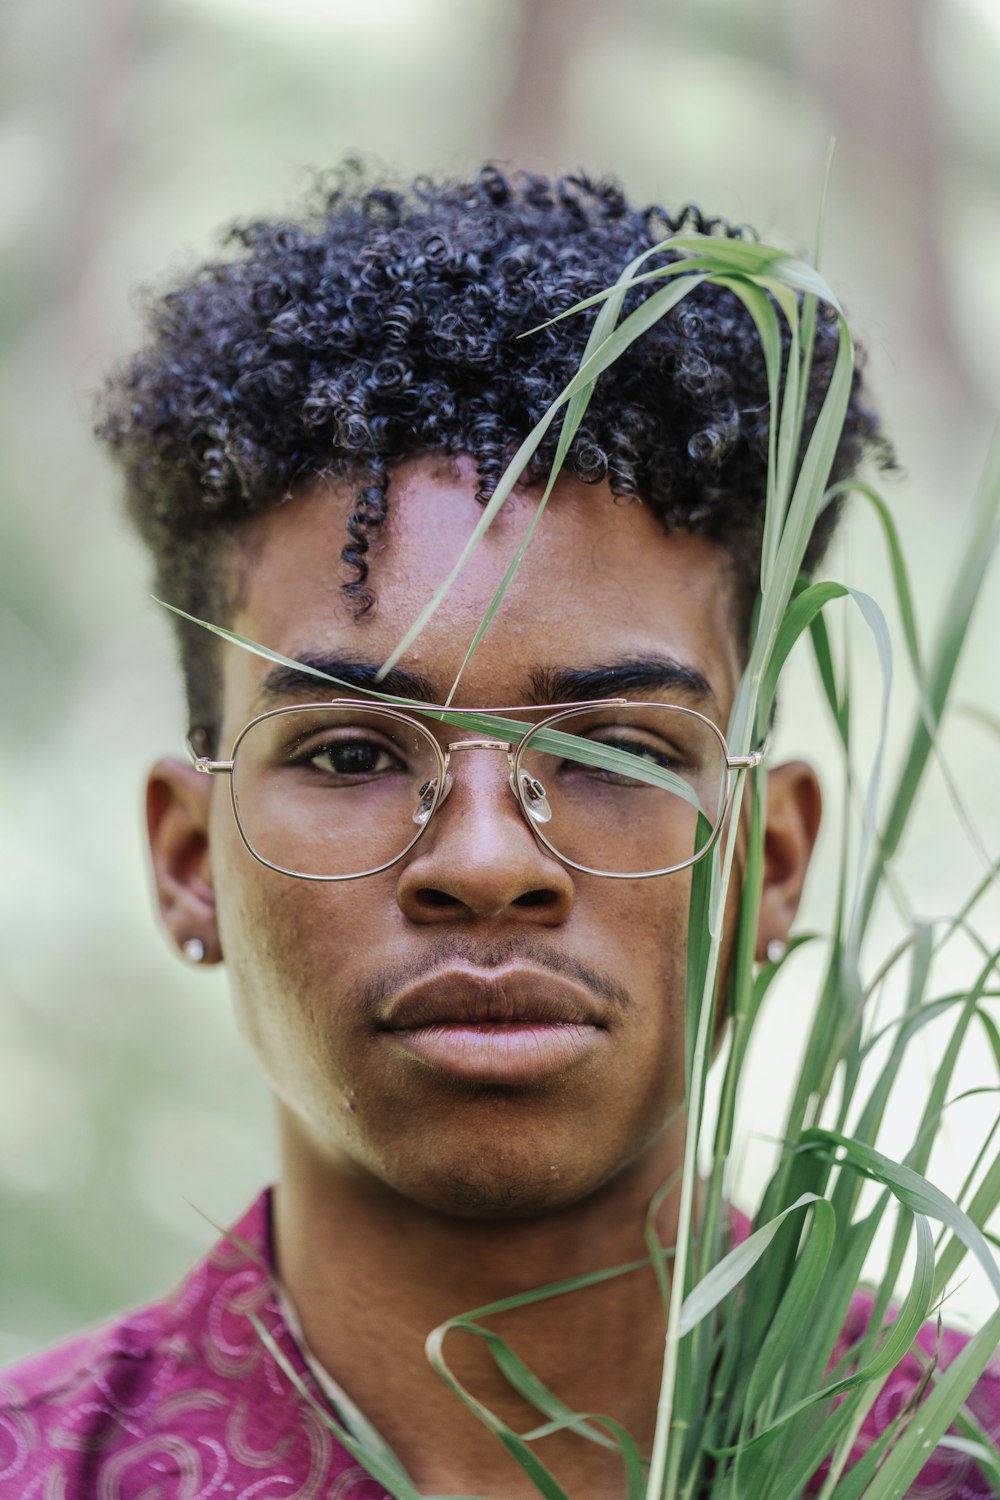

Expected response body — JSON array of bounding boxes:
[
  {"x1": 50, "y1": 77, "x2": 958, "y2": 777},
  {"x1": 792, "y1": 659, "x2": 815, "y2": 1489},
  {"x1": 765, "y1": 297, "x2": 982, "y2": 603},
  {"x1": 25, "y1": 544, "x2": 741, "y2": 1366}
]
[{"x1": 396, "y1": 747, "x2": 574, "y2": 927}]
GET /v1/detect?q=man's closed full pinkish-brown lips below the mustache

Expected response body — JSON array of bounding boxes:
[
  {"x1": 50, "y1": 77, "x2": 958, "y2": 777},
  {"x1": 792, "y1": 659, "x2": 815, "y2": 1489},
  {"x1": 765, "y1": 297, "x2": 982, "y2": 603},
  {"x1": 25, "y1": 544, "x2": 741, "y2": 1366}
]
[{"x1": 379, "y1": 968, "x2": 606, "y2": 1086}]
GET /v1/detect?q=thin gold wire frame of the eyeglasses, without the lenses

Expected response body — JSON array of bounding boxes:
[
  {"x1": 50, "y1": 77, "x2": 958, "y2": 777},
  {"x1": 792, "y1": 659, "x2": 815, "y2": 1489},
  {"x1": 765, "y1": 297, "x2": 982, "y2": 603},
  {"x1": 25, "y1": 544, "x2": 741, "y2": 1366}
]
[{"x1": 187, "y1": 698, "x2": 766, "y2": 881}]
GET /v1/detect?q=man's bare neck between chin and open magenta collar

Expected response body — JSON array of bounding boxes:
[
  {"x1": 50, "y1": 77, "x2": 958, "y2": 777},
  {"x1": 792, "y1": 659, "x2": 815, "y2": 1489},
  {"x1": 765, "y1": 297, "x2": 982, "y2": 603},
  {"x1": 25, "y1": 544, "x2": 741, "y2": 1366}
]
[{"x1": 274, "y1": 1118, "x2": 682, "y2": 1500}]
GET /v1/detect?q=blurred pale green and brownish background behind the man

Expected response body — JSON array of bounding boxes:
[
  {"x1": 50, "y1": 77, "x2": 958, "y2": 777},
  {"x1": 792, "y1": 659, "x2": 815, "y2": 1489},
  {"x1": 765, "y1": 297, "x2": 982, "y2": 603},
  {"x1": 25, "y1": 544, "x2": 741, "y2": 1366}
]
[{"x1": 0, "y1": 0, "x2": 1000, "y2": 1362}]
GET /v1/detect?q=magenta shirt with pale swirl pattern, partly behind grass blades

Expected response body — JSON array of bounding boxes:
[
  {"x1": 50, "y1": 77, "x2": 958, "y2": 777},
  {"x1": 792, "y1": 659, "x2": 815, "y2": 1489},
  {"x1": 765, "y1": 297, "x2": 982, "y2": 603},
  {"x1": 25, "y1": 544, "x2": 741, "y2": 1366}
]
[{"x1": 0, "y1": 1193, "x2": 1000, "y2": 1500}]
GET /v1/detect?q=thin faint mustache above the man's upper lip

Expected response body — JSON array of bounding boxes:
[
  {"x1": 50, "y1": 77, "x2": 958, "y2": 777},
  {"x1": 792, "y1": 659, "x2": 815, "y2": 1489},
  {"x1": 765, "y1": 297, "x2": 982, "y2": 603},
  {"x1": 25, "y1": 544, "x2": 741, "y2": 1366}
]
[{"x1": 352, "y1": 938, "x2": 634, "y2": 1017}]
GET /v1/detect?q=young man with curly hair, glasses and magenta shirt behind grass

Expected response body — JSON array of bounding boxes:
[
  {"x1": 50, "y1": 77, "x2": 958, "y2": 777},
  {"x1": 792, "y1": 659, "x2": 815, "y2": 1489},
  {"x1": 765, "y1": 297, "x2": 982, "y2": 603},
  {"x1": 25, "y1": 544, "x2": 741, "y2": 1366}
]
[{"x1": 0, "y1": 168, "x2": 987, "y2": 1500}]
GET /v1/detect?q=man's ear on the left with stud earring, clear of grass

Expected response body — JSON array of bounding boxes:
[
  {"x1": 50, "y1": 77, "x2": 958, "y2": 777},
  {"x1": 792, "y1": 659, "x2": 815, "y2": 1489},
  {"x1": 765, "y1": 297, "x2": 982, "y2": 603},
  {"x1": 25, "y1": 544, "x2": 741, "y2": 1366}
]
[{"x1": 145, "y1": 759, "x2": 222, "y2": 963}]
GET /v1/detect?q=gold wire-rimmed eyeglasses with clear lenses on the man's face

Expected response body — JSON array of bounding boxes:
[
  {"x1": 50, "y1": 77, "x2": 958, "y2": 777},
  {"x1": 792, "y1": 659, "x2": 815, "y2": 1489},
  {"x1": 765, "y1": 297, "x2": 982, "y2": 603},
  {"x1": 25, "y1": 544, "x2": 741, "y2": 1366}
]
[{"x1": 189, "y1": 699, "x2": 765, "y2": 881}]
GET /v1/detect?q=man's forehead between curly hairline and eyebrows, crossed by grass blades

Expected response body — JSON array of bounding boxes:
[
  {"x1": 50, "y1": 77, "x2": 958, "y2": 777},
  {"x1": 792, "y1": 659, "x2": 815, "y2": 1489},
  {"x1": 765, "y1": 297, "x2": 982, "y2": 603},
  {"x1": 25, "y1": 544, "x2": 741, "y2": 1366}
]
[{"x1": 223, "y1": 456, "x2": 742, "y2": 719}]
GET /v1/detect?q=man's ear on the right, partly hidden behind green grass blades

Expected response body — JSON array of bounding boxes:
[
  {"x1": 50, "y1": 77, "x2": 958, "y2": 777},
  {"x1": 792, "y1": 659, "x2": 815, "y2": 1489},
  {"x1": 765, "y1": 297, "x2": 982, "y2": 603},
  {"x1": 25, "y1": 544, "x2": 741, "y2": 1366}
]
[{"x1": 757, "y1": 761, "x2": 823, "y2": 963}]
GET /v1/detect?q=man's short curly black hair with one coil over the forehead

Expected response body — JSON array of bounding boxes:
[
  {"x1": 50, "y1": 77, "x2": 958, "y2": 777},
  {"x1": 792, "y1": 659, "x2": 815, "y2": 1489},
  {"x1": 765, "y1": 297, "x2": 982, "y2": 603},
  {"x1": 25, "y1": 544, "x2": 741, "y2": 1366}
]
[{"x1": 97, "y1": 162, "x2": 891, "y2": 738}]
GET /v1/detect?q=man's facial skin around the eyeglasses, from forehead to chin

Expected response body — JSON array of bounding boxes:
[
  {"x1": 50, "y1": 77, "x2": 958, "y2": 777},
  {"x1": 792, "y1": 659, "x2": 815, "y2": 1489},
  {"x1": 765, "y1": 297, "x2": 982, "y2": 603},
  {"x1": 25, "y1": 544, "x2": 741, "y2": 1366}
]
[{"x1": 172, "y1": 458, "x2": 758, "y2": 1217}]
